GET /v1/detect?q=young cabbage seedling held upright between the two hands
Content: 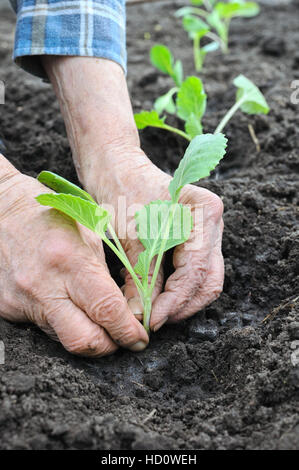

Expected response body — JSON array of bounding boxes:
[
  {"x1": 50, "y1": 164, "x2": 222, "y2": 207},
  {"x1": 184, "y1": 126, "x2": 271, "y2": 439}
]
[{"x1": 36, "y1": 133, "x2": 227, "y2": 332}]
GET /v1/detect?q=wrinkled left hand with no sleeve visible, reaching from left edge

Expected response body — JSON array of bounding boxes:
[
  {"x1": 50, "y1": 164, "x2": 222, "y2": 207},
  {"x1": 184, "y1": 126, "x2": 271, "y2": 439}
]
[{"x1": 0, "y1": 163, "x2": 148, "y2": 356}]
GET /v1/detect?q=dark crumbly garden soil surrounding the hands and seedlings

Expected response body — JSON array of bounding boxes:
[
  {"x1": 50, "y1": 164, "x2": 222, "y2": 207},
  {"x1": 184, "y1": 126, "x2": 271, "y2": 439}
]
[{"x1": 0, "y1": 1, "x2": 299, "y2": 449}]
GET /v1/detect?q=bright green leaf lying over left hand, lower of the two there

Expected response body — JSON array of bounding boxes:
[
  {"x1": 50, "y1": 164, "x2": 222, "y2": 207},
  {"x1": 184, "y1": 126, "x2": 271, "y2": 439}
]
[{"x1": 35, "y1": 193, "x2": 110, "y2": 237}]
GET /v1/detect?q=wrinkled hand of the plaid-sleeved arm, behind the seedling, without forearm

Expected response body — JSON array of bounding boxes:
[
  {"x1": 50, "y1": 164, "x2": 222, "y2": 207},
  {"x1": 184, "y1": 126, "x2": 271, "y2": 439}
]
[{"x1": 98, "y1": 149, "x2": 224, "y2": 331}]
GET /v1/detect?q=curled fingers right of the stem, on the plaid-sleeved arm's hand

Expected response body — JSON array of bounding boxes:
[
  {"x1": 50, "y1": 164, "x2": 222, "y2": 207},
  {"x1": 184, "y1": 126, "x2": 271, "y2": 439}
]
[{"x1": 152, "y1": 185, "x2": 224, "y2": 329}]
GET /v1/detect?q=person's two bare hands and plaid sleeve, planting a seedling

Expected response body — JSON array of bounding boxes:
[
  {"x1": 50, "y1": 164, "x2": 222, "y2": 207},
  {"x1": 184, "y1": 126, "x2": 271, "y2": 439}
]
[{"x1": 0, "y1": 0, "x2": 223, "y2": 356}]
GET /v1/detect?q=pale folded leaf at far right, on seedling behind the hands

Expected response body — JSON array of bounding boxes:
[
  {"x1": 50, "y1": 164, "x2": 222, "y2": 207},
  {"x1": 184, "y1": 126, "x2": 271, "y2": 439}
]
[{"x1": 234, "y1": 75, "x2": 270, "y2": 114}]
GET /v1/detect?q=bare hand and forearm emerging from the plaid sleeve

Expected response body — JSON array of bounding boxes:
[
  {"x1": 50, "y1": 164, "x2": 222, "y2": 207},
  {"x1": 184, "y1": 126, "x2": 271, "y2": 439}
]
[{"x1": 43, "y1": 57, "x2": 224, "y2": 338}]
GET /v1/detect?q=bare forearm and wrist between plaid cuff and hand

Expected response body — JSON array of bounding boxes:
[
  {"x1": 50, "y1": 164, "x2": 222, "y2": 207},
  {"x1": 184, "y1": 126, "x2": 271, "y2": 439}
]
[{"x1": 42, "y1": 56, "x2": 139, "y2": 190}]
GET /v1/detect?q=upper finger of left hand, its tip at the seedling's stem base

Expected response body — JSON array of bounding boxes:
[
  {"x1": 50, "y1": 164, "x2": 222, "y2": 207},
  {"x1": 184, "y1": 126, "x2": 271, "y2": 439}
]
[{"x1": 67, "y1": 259, "x2": 148, "y2": 351}]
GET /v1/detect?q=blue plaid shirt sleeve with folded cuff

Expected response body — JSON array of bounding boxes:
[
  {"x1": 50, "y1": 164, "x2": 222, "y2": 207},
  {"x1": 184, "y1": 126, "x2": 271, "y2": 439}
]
[{"x1": 11, "y1": 0, "x2": 126, "y2": 78}]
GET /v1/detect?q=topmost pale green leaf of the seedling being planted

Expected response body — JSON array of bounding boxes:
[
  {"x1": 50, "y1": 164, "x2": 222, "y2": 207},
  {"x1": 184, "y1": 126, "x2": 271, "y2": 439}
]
[{"x1": 168, "y1": 134, "x2": 227, "y2": 202}]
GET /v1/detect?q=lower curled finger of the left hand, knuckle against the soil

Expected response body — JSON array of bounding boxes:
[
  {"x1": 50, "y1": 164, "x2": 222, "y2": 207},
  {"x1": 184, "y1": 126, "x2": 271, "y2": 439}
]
[{"x1": 42, "y1": 300, "x2": 117, "y2": 357}]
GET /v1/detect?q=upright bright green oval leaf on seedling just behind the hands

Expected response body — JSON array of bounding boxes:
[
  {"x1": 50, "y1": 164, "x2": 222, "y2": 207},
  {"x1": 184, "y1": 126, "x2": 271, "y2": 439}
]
[{"x1": 176, "y1": 77, "x2": 207, "y2": 121}]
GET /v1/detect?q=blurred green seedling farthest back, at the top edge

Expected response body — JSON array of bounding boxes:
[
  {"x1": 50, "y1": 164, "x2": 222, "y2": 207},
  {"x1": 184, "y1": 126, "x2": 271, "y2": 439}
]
[{"x1": 176, "y1": 0, "x2": 260, "y2": 55}]
